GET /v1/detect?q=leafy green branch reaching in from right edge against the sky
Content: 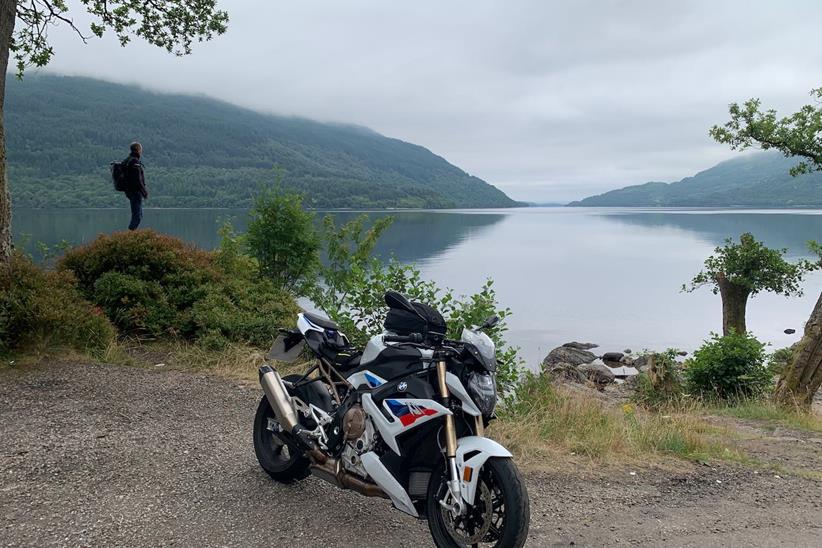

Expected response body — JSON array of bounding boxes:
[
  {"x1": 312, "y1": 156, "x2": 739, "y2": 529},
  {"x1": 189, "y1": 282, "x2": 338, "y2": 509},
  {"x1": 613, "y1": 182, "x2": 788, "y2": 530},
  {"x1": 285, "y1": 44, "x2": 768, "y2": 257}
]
[{"x1": 708, "y1": 88, "x2": 822, "y2": 176}]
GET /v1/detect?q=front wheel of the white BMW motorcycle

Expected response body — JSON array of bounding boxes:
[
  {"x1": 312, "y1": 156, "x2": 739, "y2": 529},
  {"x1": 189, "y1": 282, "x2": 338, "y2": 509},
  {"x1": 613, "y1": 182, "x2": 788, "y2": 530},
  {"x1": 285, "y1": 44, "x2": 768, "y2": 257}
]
[{"x1": 427, "y1": 458, "x2": 531, "y2": 548}]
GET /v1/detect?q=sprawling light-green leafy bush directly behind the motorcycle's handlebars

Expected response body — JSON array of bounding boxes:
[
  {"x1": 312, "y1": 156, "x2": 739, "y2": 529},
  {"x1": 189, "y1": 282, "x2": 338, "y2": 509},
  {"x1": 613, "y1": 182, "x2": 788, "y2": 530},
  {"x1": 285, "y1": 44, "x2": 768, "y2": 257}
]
[{"x1": 312, "y1": 215, "x2": 522, "y2": 390}]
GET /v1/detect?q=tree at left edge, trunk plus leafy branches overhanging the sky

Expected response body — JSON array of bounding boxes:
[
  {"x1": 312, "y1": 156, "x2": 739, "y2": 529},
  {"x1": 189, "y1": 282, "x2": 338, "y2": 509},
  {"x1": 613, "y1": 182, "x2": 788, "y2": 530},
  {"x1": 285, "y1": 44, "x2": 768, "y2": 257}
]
[{"x1": 0, "y1": 0, "x2": 228, "y2": 264}]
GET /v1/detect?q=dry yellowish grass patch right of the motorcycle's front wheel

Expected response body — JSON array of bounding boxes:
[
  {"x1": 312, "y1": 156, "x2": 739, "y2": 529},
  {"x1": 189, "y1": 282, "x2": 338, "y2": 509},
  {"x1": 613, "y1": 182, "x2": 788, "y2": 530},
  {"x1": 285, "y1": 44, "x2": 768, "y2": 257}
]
[{"x1": 491, "y1": 376, "x2": 745, "y2": 463}]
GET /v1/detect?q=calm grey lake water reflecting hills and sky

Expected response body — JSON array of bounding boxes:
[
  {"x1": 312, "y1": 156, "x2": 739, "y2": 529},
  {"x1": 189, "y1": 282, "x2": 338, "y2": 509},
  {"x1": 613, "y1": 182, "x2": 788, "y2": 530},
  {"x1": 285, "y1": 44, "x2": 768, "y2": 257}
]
[{"x1": 14, "y1": 208, "x2": 822, "y2": 363}]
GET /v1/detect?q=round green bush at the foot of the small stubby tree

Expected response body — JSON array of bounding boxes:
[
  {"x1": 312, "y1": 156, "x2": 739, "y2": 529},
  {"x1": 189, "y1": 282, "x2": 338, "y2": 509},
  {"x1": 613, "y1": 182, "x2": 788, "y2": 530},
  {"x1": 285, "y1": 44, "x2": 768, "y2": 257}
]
[{"x1": 685, "y1": 332, "x2": 772, "y2": 399}]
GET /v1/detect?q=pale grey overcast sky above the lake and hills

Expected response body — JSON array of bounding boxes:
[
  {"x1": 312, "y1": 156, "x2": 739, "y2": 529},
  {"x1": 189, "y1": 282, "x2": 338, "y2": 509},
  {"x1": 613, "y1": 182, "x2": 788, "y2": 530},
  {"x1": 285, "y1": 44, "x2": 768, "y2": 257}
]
[{"x1": 38, "y1": 0, "x2": 822, "y2": 201}]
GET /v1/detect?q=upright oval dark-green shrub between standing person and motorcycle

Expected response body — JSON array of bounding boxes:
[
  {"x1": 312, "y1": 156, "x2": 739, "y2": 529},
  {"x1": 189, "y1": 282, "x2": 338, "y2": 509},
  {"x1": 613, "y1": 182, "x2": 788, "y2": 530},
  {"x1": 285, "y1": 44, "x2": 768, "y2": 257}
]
[{"x1": 245, "y1": 183, "x2": 320, "y2": 295}]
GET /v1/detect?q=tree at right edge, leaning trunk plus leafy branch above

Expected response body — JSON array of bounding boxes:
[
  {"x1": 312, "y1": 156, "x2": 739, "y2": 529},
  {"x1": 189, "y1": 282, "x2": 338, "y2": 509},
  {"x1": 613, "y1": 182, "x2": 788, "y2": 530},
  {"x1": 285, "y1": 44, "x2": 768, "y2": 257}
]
[{"x1": 709, "y1": 88, "x2": 822, "y2": 408}]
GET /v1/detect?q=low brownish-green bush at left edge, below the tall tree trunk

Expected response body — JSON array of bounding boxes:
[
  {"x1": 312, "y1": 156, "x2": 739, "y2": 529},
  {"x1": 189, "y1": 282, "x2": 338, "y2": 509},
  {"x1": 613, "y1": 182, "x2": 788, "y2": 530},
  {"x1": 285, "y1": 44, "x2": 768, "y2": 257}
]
[{"x1": 0, "y1": 253, "x2": 116, "y2": 353}]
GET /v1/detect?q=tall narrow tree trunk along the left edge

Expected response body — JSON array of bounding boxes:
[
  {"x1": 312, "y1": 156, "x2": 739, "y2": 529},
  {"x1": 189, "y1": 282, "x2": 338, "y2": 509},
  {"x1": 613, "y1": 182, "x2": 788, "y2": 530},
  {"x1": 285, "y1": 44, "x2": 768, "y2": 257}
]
[{"x1": 0, "y1": 0, "x2": 17, "y2": 264}]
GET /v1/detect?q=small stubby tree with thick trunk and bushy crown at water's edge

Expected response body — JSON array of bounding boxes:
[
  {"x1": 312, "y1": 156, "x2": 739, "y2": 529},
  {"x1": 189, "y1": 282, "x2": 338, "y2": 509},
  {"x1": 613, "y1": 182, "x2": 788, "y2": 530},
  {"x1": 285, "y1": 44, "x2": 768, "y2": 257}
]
[{"x1": 682, "y1": 233, "x2": 817, "y2": 335}]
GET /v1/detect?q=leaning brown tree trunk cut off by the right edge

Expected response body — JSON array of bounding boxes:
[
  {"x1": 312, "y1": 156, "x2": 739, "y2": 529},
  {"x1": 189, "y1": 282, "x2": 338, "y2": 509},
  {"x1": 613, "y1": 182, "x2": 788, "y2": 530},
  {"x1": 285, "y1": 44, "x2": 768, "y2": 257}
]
[{"x1": 774, "y1": 293, "x2": 822, "y2": 408}]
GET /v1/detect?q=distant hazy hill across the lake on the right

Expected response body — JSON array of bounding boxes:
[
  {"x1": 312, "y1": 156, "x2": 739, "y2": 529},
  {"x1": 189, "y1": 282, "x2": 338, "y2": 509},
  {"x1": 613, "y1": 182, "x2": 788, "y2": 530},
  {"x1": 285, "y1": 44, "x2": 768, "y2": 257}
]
[{"x1": 568, "y1": 152, "x2": 822, "y2": 208}]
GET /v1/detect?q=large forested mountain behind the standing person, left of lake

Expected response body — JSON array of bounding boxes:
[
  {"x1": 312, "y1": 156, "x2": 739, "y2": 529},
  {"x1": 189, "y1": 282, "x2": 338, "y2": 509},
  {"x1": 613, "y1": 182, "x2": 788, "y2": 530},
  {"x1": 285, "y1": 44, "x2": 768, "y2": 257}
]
[{"x1": 5, "y1": 75, "x2": 518, "y2": 208}]
